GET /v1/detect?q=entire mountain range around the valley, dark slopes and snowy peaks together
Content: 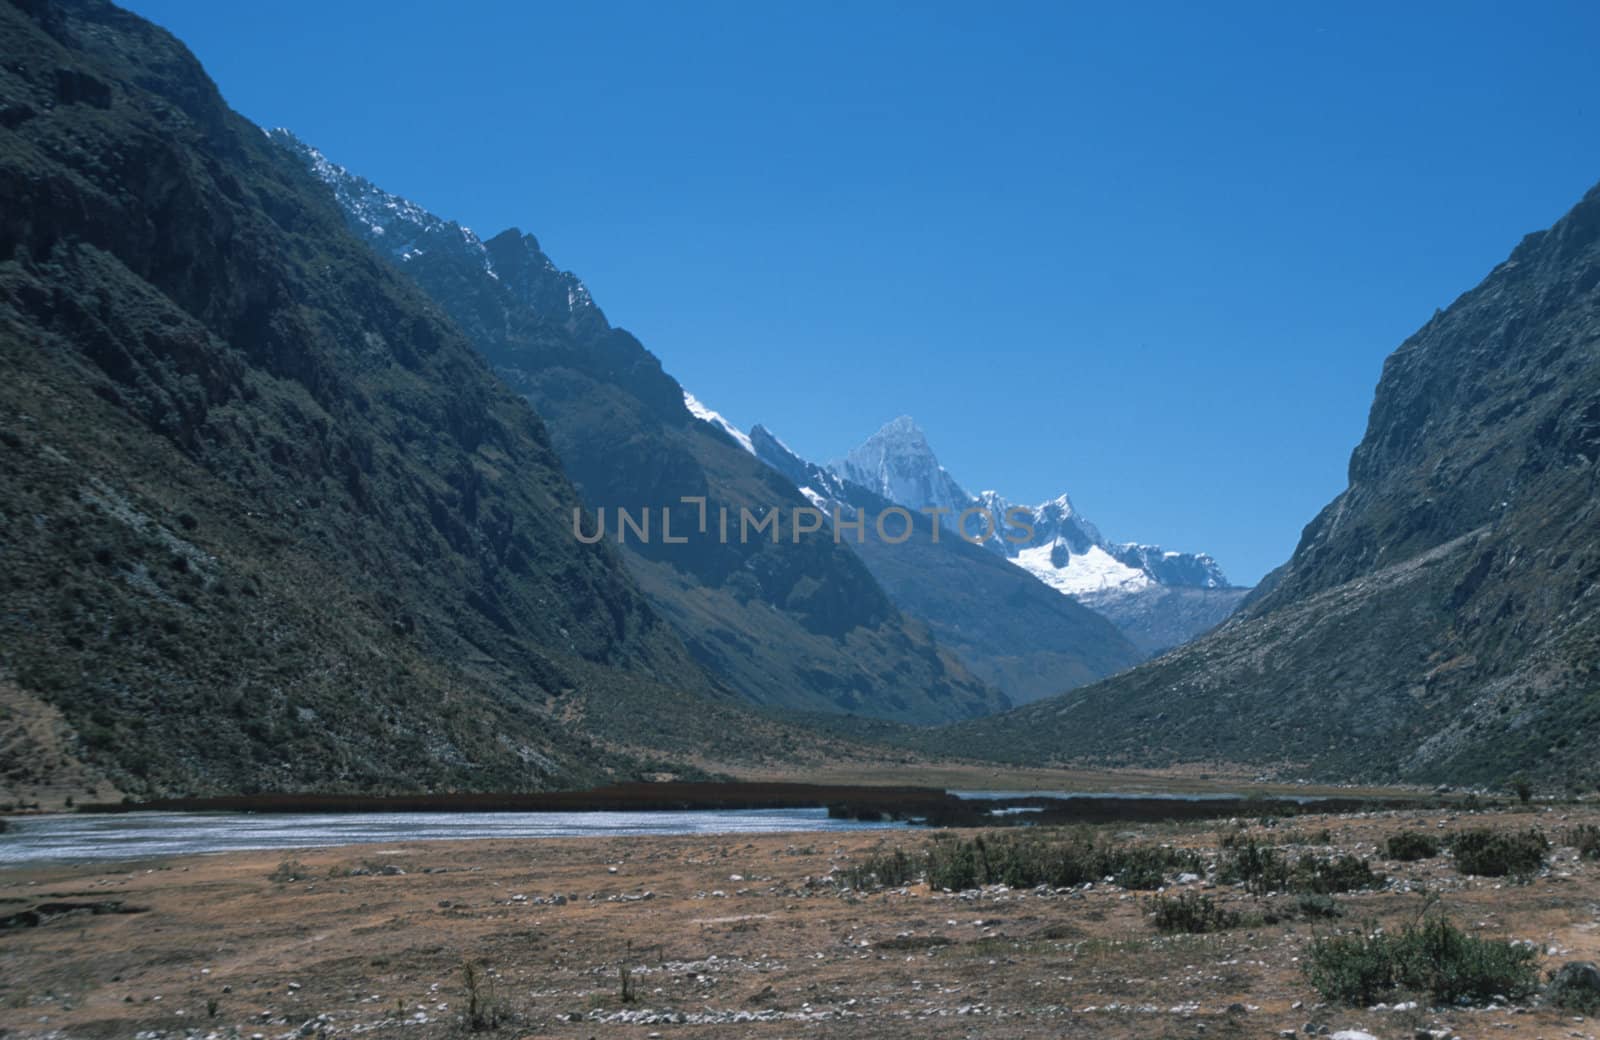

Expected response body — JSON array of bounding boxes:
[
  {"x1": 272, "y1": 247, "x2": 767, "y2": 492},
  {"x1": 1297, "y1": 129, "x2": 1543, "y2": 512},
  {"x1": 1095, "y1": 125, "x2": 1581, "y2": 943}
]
[{"x1": 0, "y1": 0, "x2": 1600, "y2": 798}]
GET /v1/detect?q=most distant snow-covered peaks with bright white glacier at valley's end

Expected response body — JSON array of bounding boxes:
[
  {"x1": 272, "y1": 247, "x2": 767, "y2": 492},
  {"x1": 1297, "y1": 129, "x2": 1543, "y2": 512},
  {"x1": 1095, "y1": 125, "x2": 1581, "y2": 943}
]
[{"x1": 829, "y1": 416, "x2": 1250, "y2": 656}]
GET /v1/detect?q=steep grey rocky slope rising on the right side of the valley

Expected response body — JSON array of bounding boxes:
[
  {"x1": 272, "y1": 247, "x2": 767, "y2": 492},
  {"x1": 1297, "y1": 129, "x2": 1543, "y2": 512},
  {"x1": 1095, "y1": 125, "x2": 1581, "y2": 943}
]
[{"x1": 944, "y1": 189, "x2": 1600, "y2": 789}]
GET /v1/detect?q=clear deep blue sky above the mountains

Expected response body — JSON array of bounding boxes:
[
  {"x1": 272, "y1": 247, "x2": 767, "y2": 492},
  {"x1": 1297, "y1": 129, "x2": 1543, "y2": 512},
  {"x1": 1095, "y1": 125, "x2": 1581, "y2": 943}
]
[{"x1": 131, "y1": 0, "x2": 1600, "y2": 582}]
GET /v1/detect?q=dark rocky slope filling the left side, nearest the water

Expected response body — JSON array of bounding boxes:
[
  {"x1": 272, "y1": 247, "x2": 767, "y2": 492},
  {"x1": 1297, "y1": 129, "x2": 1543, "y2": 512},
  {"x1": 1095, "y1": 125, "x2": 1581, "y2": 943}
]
[{"x1": 0, "y1": 0, "x2": 889, "y2": 800}]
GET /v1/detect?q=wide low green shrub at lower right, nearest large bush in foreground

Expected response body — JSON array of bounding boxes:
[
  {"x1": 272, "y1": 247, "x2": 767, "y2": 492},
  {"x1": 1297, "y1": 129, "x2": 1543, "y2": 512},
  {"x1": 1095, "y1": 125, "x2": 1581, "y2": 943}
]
[{"x1": 1304, "y1": 917, "x2": 1539, "y2": 1006}]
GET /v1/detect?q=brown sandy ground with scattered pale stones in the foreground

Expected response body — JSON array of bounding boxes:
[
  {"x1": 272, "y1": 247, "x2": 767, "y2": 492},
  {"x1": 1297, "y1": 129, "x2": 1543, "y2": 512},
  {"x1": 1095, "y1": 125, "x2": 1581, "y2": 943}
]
[{"x1": 0, "y1": 806, "x2": 1600, "y2": 1040}]
